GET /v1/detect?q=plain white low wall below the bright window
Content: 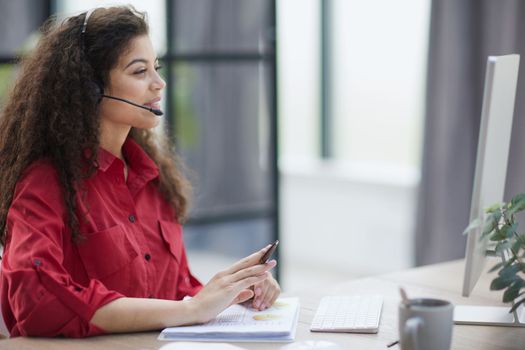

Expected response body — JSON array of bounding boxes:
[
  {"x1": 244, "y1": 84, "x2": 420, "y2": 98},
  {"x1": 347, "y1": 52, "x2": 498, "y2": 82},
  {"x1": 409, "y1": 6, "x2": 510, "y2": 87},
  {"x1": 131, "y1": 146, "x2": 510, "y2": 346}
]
[{"x1": 281, "y1": 162, "x2": 418, "y2": 276}]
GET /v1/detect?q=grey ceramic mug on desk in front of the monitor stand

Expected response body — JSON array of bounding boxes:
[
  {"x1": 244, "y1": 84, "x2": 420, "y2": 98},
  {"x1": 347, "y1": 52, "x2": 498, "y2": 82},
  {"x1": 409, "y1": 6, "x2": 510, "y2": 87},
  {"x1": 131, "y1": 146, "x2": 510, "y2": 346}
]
[{"x1": 399, "y1": 298, "x2": 454, "y2": 350}]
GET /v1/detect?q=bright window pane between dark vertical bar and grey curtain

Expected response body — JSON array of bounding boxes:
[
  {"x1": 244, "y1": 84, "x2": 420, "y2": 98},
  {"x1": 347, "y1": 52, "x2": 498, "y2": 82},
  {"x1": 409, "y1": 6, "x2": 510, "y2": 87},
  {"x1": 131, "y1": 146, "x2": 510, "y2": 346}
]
[{"x1": 329, "y1": 0, "x2": 430, "y2": 167}]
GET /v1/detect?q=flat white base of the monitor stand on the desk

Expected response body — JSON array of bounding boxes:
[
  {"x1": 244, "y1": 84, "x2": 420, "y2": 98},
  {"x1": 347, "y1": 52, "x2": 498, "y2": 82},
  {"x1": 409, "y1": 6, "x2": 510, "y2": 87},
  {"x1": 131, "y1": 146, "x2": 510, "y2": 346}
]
[{"x1": 454, "y1": 304, "x2": 525, "y2": 327}]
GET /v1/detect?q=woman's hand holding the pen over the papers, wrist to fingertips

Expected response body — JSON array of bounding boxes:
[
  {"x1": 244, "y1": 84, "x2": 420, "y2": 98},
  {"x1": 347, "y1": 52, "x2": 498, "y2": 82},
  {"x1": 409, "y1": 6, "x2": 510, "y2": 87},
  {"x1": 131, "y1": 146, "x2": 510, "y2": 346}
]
[{"x1": 190, "y1": 245, "x2": 278, "y2": 323}]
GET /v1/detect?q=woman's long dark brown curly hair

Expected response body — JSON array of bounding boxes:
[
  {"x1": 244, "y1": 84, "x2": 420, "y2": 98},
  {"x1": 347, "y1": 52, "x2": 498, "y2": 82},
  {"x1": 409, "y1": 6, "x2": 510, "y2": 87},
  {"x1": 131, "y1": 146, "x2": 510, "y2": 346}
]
[{"x1": 0, "y1": 6, "x2": 191, "y2": 245}]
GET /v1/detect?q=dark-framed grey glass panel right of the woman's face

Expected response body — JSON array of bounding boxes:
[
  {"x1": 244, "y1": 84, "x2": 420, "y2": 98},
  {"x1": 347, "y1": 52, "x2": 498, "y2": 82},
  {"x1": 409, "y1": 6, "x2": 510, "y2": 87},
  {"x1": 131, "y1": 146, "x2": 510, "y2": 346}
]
[{"x1": 166, "y1": 0, "x2": 278, "y2": 274}]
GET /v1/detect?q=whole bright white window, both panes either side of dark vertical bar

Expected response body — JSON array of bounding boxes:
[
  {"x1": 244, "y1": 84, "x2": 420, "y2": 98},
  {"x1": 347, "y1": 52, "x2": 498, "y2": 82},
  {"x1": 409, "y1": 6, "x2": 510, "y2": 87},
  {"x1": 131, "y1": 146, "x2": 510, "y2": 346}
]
[{"x1": 278, "y1": 0, "x2": 430, "y2": 174}]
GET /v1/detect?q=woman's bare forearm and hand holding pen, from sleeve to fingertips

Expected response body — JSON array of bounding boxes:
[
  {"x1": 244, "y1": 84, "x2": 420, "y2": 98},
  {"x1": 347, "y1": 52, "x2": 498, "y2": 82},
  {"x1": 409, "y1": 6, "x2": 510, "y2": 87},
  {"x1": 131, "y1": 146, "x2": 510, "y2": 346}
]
[{"x1": 91, "y1": 246, "x2": 276, "y2": 333}]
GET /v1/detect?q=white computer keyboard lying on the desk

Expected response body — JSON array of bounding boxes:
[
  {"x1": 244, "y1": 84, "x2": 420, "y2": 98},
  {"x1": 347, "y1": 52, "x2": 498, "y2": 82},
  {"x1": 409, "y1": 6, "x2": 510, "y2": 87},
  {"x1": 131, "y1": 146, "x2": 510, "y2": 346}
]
[{"x1": 310, "y1": 295, "x2": 383, "y2": 333}]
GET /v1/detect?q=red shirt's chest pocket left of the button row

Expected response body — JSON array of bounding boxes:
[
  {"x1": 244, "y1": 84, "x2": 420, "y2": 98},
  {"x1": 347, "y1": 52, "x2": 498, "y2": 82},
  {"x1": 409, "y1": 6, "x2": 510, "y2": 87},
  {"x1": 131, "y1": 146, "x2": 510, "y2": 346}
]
[{"x1": 77, "y1": 225, "x2": 138, "y2": 282}]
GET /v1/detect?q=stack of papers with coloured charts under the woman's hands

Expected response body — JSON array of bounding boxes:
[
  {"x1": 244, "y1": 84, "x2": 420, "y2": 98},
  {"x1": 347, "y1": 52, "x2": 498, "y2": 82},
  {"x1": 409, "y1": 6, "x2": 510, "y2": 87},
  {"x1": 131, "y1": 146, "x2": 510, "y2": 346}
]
[{"x1": 158, "y1": 298, "x2": 299, "y2": 342}]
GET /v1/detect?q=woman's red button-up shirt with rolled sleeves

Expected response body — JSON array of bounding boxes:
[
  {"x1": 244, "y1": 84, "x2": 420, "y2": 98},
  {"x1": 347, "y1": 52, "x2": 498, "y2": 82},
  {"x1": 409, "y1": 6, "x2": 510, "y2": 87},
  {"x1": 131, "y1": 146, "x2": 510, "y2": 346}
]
[{"x1": 0, "y1": 139, "x2": 202, "y2": 337}]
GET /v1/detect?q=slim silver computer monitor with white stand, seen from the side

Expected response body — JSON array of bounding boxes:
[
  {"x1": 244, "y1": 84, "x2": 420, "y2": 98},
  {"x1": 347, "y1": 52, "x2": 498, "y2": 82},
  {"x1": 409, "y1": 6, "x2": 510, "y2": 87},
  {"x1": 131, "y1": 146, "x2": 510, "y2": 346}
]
[{"x1": 454, "y1": 54, "x2": 525, "y2": 327}]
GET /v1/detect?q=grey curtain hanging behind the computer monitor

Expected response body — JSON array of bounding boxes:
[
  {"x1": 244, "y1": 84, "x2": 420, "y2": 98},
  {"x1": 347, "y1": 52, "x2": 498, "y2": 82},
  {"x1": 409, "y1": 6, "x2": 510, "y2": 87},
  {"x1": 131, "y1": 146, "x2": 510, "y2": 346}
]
[{"x1": 415, "y1": 0, "x2": 525, "y2": 265}]
